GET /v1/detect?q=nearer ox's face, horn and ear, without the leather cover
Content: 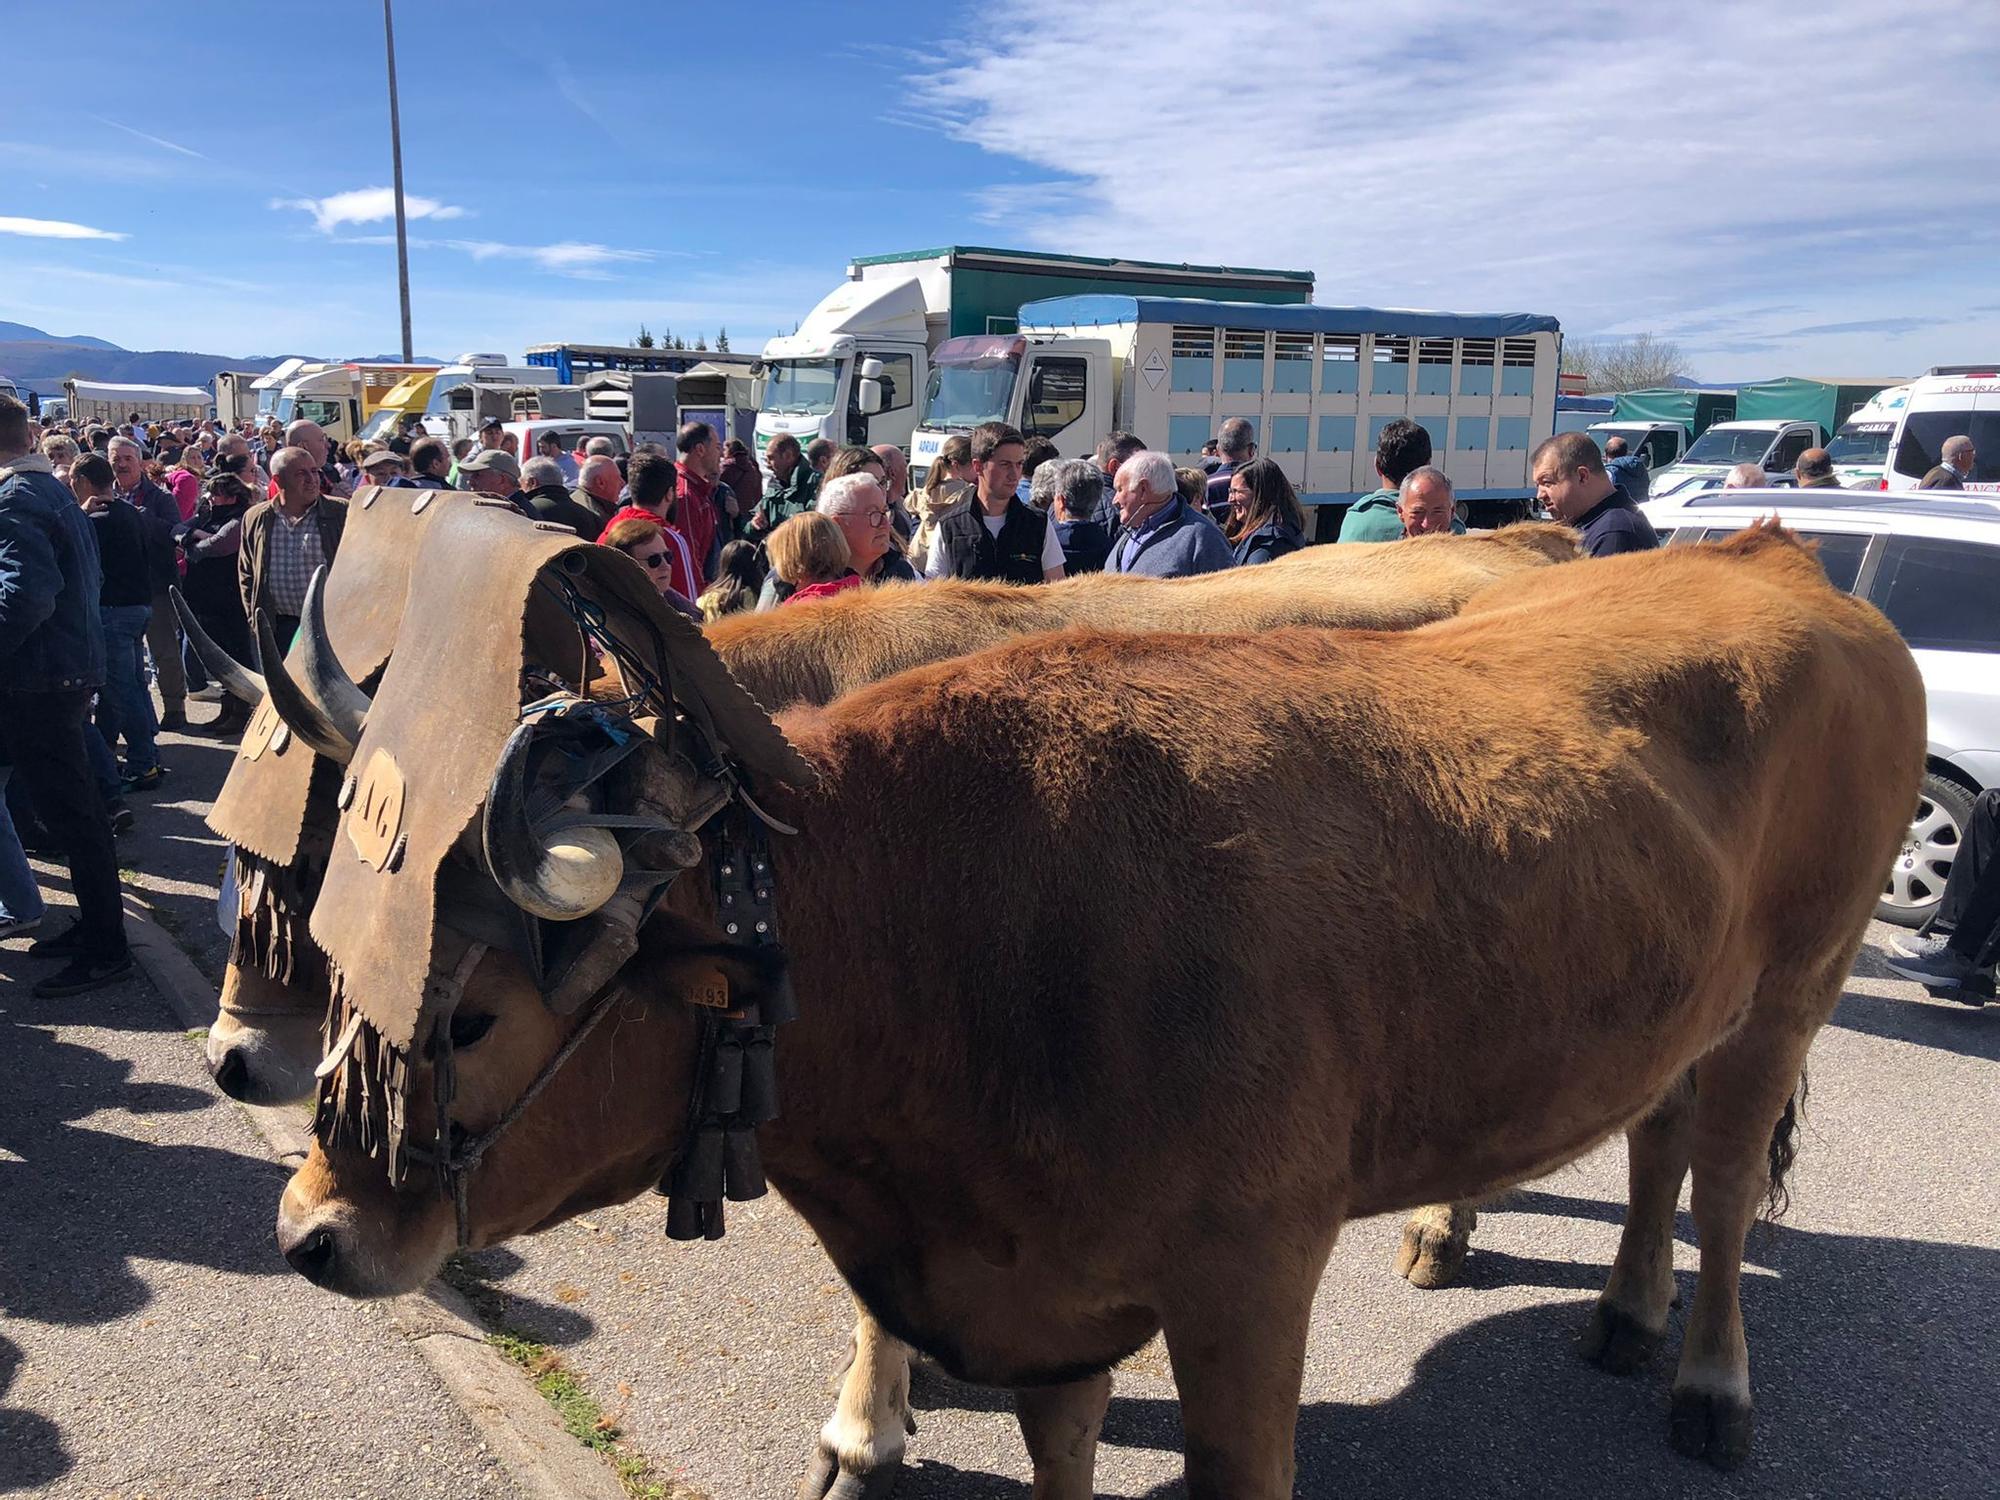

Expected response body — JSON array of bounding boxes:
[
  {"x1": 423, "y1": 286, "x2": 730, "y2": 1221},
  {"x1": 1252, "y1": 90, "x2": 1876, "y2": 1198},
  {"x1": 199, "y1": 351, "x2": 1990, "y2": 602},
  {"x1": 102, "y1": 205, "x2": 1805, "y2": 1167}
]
[{"x1": 278, "y1": 700, "x2": 782, "y2": 1296}]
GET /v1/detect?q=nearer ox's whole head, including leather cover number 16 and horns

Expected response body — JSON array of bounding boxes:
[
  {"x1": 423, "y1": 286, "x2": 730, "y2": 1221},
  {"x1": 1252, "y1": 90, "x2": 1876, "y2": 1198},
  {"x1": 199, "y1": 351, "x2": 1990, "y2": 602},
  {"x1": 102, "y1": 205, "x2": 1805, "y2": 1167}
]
[{"x1": 274, "y1": 510, "x2": 810, "y2": 1296}]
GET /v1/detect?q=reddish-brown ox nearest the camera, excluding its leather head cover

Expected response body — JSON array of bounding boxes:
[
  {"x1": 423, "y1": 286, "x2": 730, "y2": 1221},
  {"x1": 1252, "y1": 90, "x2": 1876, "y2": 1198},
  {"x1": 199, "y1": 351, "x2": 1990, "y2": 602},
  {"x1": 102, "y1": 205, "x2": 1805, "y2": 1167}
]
[{"x1": 278, "y1": 530, "x2": 1924, "y2": 1496}]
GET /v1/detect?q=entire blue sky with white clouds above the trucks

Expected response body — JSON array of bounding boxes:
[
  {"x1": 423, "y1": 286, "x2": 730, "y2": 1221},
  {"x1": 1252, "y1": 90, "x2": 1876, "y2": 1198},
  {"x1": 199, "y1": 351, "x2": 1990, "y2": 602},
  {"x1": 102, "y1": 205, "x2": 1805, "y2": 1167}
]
[{"x1": 0, "y1": 0, "x2": 2000, "y2": 378}]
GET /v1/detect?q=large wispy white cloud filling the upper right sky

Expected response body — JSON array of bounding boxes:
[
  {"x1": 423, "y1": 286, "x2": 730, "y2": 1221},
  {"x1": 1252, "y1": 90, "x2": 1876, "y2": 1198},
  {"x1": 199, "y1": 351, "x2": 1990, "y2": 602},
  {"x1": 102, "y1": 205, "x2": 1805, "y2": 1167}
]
[{"x1": 910, "y1": 0, "x2": 2000, "y2": 376}]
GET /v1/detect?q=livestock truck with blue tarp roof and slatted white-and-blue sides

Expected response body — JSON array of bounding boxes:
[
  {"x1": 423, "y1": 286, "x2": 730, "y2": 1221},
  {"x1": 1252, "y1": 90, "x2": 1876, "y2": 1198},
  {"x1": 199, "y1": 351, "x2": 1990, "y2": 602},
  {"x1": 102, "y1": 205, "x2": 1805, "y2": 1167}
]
[{"x1": 910, "y1": 294, "x2": 1562, "y2": 540}]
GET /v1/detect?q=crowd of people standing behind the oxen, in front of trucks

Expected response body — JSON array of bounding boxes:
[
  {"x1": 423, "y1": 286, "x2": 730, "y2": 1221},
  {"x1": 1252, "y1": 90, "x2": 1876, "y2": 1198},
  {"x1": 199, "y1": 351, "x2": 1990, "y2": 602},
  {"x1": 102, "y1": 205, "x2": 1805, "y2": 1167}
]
[{"x1": 0, "y1": 382, "x2": 2000, "y2": 994}]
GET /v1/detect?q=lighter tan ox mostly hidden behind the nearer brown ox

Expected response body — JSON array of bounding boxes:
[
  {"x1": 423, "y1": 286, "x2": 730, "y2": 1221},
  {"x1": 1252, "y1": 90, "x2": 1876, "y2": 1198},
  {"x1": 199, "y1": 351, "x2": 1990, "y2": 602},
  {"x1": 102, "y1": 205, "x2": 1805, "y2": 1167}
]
[{"x1": 208, "y1": 524, "x2": 1576, "y2": 1482}]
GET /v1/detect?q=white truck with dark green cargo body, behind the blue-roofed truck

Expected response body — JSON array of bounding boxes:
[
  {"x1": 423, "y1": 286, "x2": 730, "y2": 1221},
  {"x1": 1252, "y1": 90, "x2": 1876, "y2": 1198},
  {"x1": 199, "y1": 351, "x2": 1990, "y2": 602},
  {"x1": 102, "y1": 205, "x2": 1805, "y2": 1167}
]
[{"x1": 756, "y1": 246, "x2": 1312, "y2": 462}]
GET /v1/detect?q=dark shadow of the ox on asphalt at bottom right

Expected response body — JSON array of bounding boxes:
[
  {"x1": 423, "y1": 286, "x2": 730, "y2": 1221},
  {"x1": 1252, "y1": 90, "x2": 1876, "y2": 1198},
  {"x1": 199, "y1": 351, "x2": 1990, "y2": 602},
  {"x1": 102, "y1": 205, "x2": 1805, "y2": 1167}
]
[{"x1": 1072, "y1": 1194, "x2": 2000, "y2": 1500}]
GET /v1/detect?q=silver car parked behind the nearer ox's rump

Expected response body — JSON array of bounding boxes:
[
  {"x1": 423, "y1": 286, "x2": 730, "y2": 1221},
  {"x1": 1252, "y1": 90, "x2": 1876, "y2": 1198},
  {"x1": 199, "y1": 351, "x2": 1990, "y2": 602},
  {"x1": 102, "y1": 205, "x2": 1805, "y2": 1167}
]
[{"x1": 1642, "y1": 490, "x2": 2000, "y2": 928}]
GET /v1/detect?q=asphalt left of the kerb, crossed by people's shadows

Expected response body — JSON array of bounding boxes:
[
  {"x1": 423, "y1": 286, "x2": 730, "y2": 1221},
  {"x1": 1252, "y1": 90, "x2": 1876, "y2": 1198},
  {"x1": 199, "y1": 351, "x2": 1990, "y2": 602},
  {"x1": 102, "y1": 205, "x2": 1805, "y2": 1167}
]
[{"x1": 0, "y1": 910, "x2": 516, "y2": 1500}]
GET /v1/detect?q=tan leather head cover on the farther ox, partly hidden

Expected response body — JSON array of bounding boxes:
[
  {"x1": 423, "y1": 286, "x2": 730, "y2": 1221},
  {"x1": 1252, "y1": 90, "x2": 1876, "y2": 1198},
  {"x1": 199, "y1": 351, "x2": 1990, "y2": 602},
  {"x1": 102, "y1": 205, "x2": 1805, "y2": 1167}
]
[{"x1": 208, "y1": 484, "x2": 444, "y2": 868}]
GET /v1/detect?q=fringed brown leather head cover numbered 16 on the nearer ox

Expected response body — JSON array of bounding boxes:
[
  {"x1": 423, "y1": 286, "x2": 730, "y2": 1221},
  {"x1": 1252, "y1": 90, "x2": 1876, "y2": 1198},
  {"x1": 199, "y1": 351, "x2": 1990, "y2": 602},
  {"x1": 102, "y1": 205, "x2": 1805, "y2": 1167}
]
[{"x1": 312, "y1": 500, "x2": 810, "y2": 1176}]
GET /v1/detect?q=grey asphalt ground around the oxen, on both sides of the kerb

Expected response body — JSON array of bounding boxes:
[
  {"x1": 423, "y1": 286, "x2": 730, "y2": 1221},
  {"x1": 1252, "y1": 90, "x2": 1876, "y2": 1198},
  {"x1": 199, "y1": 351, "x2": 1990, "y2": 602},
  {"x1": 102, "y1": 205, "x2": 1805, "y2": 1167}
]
[{"x1": 0, "y1": 712, "x2": 2000, "y2": 1500}]
